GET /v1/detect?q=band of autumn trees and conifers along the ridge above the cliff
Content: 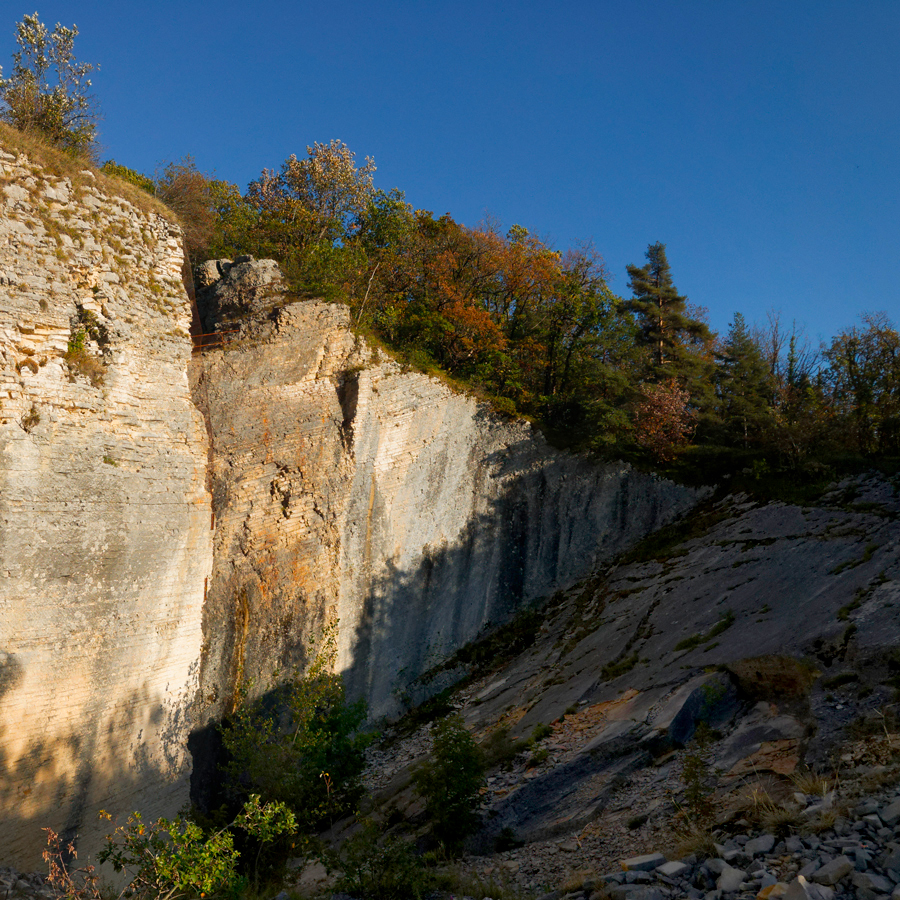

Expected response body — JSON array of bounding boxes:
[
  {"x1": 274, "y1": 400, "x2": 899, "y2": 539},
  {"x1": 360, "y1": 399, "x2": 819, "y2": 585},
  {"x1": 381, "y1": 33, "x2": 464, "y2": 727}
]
[{"x1": 103, "y1": 141, "x2": 900, "y2": 471}]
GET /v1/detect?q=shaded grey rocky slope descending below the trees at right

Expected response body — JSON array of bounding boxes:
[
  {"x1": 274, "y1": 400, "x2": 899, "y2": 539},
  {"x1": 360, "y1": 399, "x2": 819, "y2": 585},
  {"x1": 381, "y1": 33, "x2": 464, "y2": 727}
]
[{"x1": 338, "y1": 476, "x2": 900, "y2": 898}]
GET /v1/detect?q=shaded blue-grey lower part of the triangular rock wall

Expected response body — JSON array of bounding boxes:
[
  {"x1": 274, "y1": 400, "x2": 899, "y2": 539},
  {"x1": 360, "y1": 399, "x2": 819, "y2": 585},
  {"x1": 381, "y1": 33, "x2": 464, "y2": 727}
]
[{"x1": 344, "y1": 442, "x2": 693, "y2": 719}]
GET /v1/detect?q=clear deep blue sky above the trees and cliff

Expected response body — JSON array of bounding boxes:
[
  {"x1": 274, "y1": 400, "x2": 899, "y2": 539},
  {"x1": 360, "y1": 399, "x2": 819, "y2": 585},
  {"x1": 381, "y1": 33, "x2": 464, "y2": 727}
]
[{"x1": 0, "y1": 0, "x2": 900, "y2": 343}]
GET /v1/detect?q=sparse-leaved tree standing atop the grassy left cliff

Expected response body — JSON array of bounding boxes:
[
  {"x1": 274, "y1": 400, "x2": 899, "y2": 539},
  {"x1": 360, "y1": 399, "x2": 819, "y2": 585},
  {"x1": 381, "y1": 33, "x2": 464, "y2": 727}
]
[{"x1": 0, "y1": 13, "x2": 98, "y2": 153}]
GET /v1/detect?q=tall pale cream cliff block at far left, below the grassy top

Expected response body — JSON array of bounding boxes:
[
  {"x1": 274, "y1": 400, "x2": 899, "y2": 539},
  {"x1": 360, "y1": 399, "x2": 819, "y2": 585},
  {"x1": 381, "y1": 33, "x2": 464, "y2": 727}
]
[{"x1": 0, "y1": 149, "x2": 212, "y2": 868}]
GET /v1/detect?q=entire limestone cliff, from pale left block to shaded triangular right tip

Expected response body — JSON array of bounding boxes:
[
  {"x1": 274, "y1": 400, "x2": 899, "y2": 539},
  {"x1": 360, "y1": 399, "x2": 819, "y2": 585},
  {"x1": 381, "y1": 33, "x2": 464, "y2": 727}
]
[{"x1": 0, "y1": 149, "x2": 696, "y2": 868}]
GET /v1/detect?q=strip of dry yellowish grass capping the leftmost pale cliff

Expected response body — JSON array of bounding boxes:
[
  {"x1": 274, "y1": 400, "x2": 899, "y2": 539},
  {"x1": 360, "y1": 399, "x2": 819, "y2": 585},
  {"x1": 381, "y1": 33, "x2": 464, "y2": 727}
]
[{"x1": 0, "y1": 122, "x2": 184, "y2": 228}]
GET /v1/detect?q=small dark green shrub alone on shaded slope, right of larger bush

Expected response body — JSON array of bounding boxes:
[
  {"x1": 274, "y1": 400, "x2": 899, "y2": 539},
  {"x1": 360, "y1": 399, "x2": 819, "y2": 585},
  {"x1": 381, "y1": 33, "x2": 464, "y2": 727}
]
[{"x1": 414, "y1": 713, "x2": 484, "y2": 853}]
